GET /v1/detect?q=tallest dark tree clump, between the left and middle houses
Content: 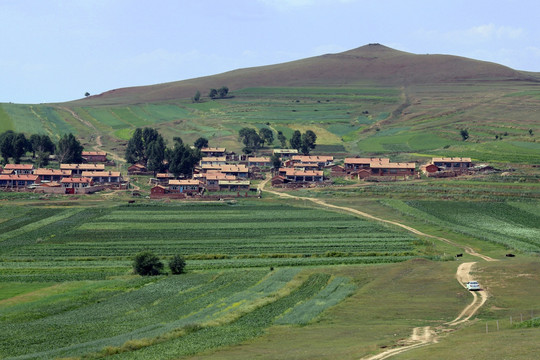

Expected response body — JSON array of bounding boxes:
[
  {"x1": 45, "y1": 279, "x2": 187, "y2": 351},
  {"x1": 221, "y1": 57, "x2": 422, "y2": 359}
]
[{"x1": 125, "y1": 127, "x2": 208, "y2": 177}]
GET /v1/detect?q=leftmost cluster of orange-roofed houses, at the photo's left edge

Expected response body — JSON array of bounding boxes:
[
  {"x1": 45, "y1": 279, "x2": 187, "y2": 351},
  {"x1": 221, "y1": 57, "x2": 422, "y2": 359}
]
[{"x1": 0, "y1": 151, "x2": 124, "y2": 194}]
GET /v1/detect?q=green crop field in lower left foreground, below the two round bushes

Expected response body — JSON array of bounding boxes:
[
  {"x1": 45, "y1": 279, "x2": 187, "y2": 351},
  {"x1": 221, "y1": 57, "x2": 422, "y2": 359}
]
[{"x1": 0, "y1": 269, "x2": 298, "y2": 358}]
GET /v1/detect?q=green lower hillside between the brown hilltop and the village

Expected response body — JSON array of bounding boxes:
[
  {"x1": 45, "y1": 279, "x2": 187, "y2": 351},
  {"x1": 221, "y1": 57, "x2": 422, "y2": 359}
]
[{"x1": 0, "y1": 83, "x2": 540, "y2": 164}]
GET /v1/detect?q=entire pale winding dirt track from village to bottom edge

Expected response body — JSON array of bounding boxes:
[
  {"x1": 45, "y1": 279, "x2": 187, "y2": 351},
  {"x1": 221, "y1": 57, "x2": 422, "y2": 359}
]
[{"x1": 258, "y1": 179, "x2": 498, "y2": 360}]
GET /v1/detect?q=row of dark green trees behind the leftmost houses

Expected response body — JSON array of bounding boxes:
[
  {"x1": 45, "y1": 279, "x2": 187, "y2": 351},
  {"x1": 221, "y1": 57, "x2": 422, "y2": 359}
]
[{"x1": 0, "y1": 130, "x2": 83, "y2": 167}]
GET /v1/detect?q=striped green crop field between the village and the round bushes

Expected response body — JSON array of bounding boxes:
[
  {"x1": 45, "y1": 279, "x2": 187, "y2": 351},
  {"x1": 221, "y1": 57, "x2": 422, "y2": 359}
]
[{"x1": 0, "y1": 202, "x2": 423, "y2": 281}]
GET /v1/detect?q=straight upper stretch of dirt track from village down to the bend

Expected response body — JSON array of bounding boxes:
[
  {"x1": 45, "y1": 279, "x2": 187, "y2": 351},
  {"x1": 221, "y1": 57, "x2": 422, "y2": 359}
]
[{"x1": 257, "y1": 179, "x2": 497, "y2": 261}]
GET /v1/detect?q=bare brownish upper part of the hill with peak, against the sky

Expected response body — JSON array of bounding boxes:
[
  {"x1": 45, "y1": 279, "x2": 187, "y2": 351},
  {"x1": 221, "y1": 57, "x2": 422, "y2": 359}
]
[{"x1": 70, "y1": 44, "x2": 540, "y2": 105}]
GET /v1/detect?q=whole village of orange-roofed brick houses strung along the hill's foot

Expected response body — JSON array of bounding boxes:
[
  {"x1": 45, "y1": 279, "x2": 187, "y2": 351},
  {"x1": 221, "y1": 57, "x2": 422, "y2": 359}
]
[{"x1": 0, "y1": 147, "x2": 473, "y2": 199}]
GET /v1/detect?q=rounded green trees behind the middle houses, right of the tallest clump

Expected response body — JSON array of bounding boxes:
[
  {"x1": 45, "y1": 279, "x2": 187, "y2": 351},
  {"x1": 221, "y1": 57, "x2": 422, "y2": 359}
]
[{"x1": 238, "y1": 127, "x2": 317, "y2": 155}]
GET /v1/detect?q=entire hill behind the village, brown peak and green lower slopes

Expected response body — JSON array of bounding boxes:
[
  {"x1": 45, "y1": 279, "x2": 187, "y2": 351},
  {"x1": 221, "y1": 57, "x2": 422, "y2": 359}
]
[{"x1": 0, "y1": 44, "x2": 540, "y2": 164}]
